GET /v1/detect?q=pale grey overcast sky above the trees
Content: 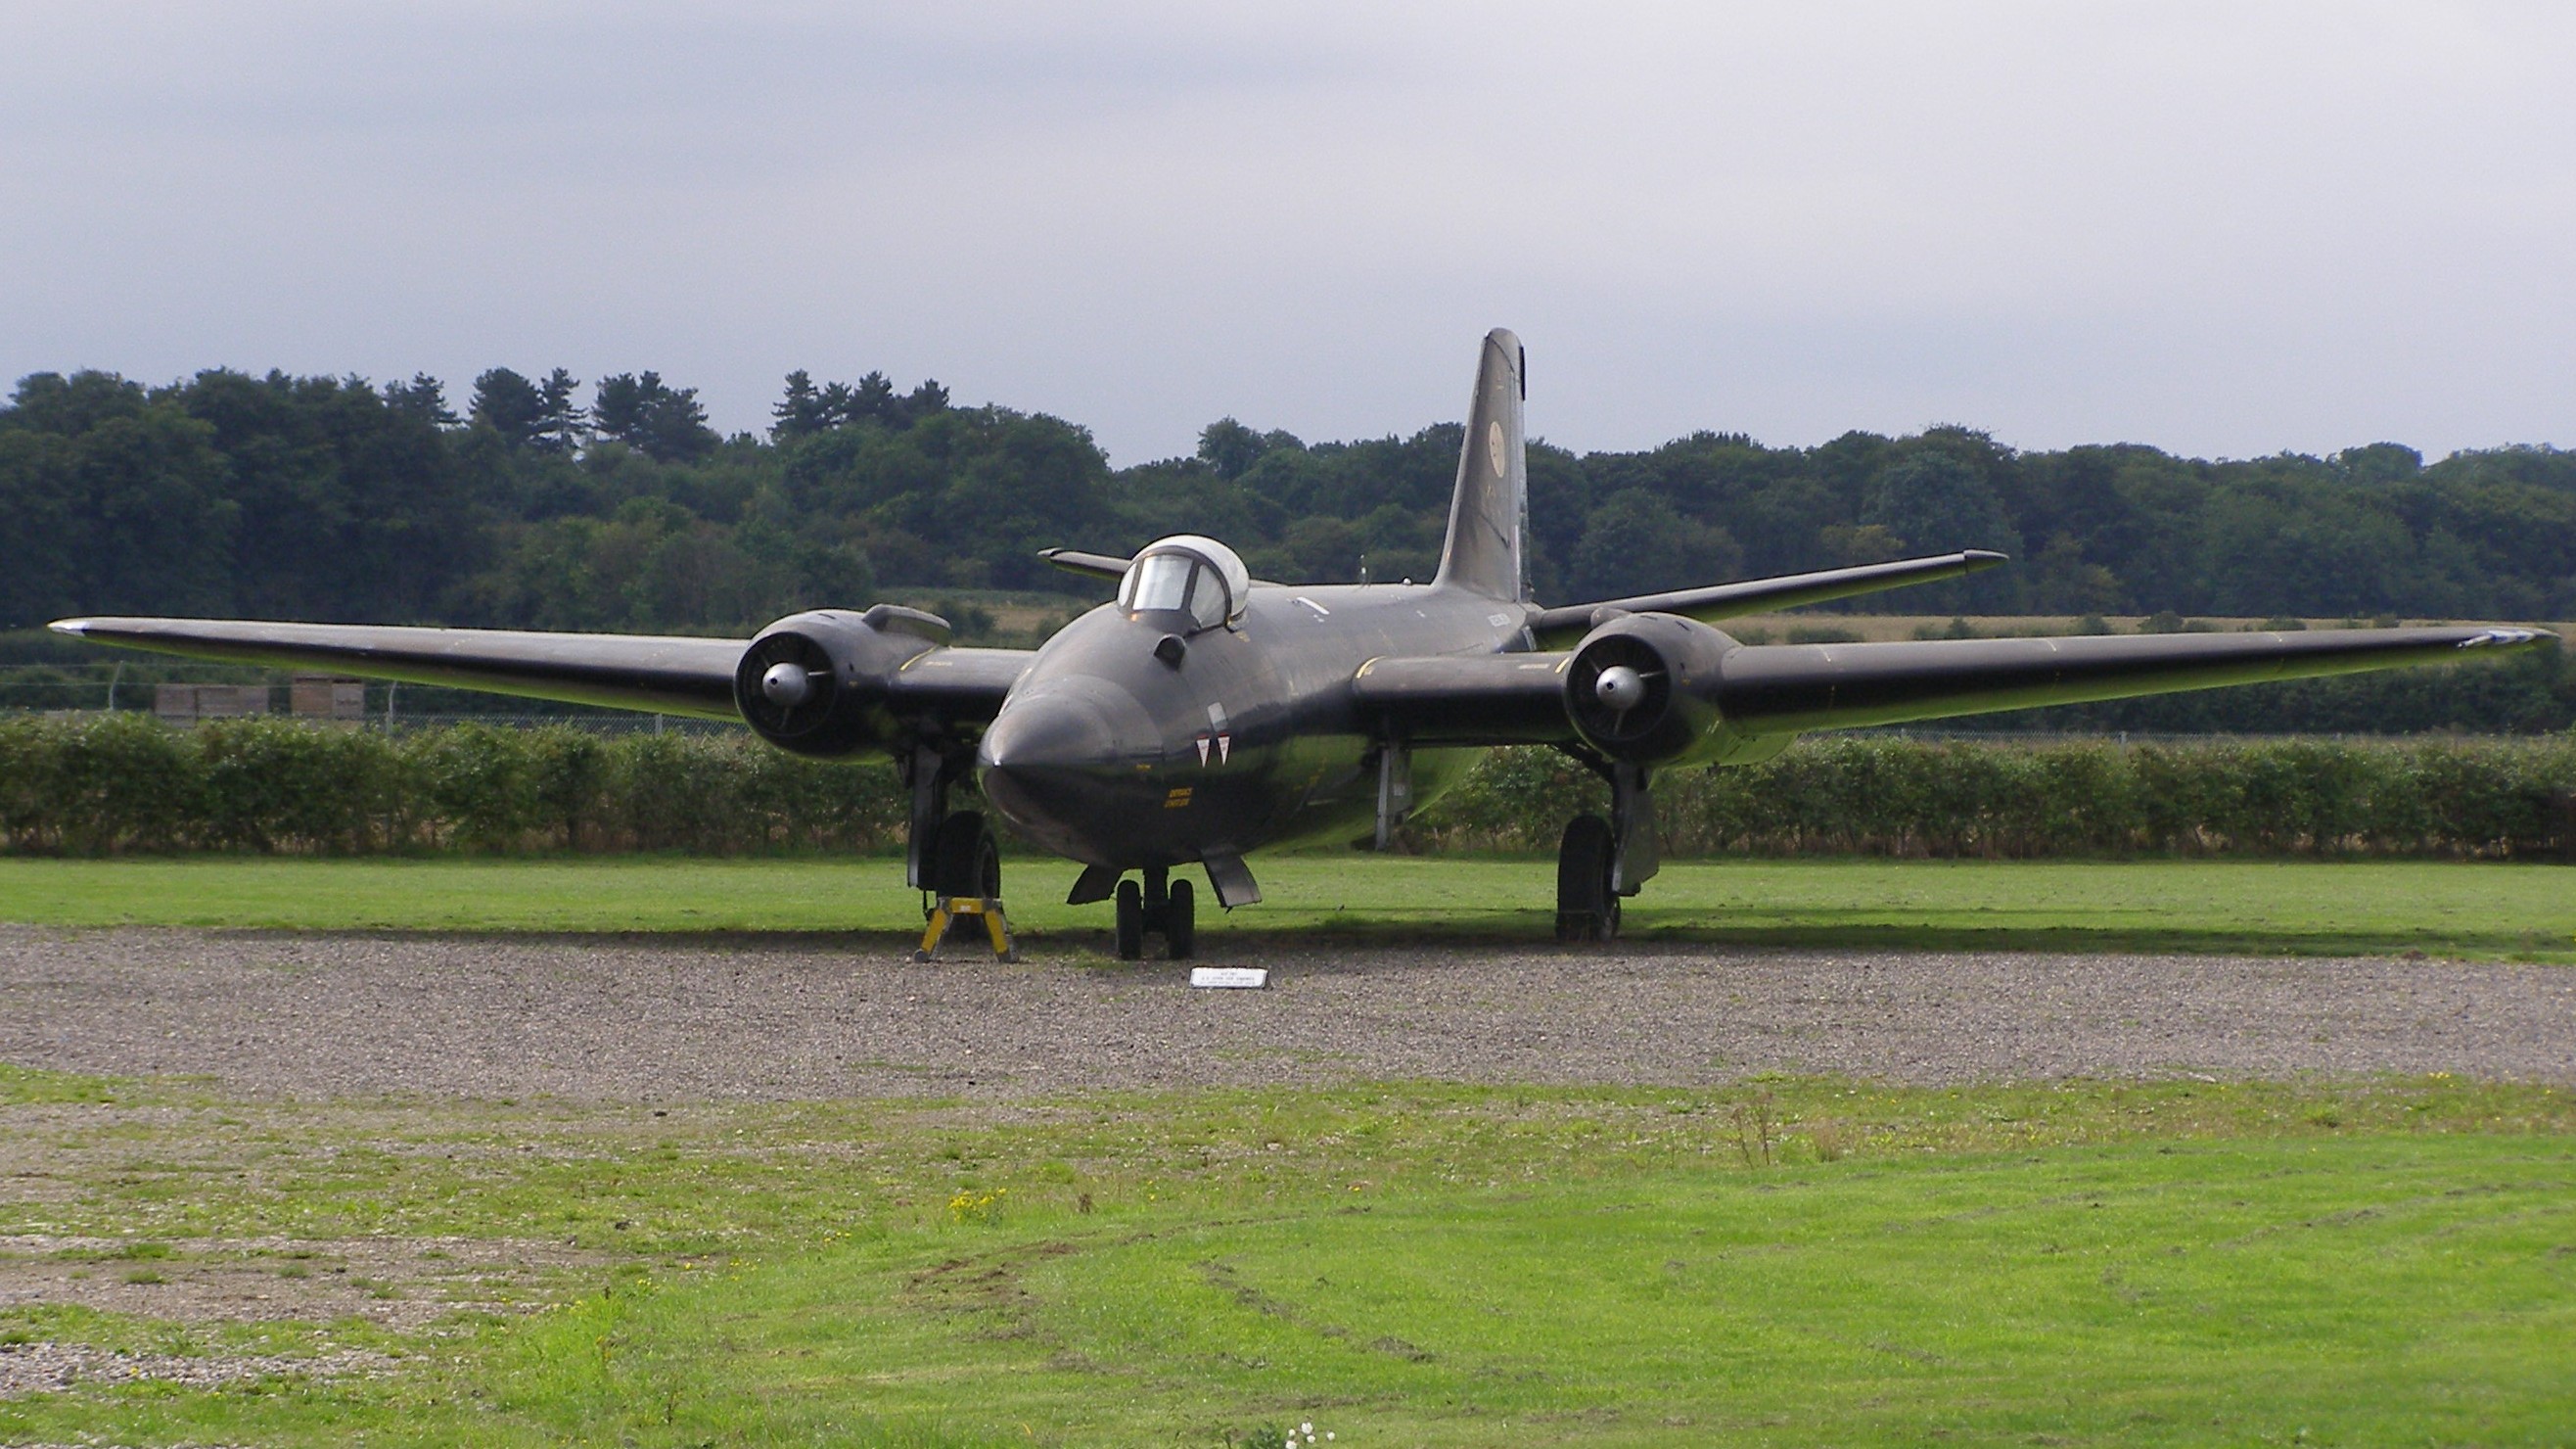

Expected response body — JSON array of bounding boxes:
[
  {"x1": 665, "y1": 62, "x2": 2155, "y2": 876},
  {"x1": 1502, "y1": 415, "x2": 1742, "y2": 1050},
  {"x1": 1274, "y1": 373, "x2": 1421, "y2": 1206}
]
[{"x1": 0, "y1": 0, "x2": 2576, "y2": 464}]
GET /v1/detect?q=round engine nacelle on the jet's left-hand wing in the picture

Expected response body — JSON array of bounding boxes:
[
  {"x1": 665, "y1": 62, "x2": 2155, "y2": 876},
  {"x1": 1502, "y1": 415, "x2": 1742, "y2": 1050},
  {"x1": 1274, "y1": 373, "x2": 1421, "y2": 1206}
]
[{"x1": 734, "y1": 603, "x2": 948, "y2": 758}]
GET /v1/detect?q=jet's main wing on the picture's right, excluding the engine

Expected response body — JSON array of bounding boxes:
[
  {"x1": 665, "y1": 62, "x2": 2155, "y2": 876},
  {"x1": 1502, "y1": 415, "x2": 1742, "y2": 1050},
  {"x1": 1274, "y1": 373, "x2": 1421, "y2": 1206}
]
[{"x1": 1353, "y1": 624, "x2": 2555, "y2": 758}]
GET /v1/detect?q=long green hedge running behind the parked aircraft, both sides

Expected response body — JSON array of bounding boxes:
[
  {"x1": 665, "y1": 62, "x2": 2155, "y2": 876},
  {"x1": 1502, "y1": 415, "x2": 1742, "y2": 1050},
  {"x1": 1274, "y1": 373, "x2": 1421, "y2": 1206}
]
[{"x1": 0, "y1": 714, "x2": 2576, "y2": 859}]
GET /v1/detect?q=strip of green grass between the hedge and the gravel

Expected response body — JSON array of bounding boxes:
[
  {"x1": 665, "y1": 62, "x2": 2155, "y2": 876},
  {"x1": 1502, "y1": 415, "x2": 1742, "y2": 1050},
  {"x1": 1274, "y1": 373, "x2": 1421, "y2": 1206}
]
[{"x1": 0, "y1": 856, "x2": 2576, "y2": 961}]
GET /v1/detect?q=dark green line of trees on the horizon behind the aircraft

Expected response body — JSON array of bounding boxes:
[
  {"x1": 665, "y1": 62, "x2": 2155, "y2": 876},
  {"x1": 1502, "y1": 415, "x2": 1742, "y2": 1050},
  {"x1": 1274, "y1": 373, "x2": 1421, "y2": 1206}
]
[{"x1": 0, "y1": 369, "x2": 2576, "y2": 631}]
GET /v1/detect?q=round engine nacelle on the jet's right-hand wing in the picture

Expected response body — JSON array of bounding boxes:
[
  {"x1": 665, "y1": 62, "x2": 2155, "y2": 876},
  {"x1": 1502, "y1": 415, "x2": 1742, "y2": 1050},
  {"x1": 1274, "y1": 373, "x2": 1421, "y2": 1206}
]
[{"x1": 1566, "y1": 614, "x2": 1736, "y2": 766}]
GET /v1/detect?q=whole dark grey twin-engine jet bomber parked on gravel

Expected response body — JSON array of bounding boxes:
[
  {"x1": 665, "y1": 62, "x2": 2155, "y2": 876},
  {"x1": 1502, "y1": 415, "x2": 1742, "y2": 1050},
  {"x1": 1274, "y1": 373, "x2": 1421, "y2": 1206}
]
[{"x1": 54, "y1": 330, "x2": 2548, "y2": 959}]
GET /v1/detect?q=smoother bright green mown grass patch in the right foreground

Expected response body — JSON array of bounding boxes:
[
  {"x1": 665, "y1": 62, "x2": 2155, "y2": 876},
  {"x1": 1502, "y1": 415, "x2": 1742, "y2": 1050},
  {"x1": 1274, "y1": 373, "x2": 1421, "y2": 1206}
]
[{"x1": 569, "y1": 1137, "x2": 2576, "y2": 1444}]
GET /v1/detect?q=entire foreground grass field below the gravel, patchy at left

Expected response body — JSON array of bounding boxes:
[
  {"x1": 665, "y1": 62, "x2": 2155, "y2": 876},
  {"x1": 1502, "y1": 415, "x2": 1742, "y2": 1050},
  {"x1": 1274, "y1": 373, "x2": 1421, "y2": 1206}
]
[{"x1": 0, "y1": 1070, "x2": 2576, "y2": 1449}]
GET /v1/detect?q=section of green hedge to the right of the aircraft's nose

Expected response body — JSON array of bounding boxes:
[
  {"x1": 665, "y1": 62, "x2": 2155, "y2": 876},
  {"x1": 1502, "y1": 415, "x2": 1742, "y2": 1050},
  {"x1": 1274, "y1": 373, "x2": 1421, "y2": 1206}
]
[{"x1": 1417, "y1": 735, "x2": 2576, "y2": 859}]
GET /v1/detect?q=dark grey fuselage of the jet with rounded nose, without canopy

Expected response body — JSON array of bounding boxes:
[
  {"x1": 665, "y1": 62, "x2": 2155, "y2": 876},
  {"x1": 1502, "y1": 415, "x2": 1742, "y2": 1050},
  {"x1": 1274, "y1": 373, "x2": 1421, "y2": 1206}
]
[{"x1": 977, "y1": 583, "x2": 1530, "y2": 868}]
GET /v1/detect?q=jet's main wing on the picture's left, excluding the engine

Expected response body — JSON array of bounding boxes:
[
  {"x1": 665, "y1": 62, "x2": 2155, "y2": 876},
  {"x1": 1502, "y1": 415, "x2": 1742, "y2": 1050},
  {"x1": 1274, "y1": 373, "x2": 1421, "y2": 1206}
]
[{"x1": 54, "y1": 619, "x2": 1031, "y2": 722}]
